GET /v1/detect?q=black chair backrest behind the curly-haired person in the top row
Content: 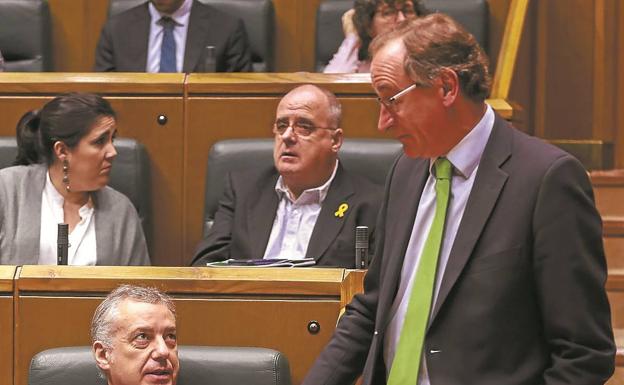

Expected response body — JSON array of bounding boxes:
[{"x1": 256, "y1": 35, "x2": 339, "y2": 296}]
[{"x1": 316, "y1": 0, "x2": 489, "y2": 71}]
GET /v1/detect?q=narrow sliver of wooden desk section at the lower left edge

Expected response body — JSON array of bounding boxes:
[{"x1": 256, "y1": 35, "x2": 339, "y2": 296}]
[{"x1": 0, "y1": 266, "x2": 16, "y2": 384}]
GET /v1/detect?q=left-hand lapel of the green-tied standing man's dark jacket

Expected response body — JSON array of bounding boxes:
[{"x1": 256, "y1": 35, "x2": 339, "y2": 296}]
[{"x1": 378, "y1": 156, "x2": 429, "y2": 330}]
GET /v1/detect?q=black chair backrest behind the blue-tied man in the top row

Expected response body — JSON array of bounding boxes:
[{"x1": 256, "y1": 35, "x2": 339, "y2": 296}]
[{"x1": 106, "y1": 0, "x2": 275, "y2": 72}]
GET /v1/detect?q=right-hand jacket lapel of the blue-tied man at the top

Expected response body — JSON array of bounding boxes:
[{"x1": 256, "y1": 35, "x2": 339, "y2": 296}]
[{"x1": 182, "y1": 0, "x2": 212, "y2": 73}]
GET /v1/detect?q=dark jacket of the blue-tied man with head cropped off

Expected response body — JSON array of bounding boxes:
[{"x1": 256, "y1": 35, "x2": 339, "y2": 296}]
[{"x1": 95, "y1": 0, "x2": 251, "y2": 73}]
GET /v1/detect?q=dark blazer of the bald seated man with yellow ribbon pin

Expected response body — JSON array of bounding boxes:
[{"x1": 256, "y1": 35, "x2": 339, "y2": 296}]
[{"x1": 192, "y1": 165, "x2": 382, "y2": 268}]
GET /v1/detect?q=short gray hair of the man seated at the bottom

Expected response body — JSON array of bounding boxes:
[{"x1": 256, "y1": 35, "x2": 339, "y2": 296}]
[{"x1": 91, "y1": 285, "x2": 176, "y2": 348}]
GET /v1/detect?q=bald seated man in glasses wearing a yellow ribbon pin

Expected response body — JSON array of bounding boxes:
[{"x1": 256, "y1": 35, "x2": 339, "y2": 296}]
[{"x1": 193, "y1": 85, "x2": 381, "y2": 268}]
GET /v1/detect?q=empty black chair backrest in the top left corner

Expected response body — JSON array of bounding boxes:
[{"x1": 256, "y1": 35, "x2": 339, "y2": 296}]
[{"x1": 0, "y1": 0, "x2": 52, "y2": 72}]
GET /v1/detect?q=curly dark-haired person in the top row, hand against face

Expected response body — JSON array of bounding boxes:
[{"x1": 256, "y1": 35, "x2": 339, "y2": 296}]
[{"x1": 323, "y1": 0, "x2": 427, "y2": 73}]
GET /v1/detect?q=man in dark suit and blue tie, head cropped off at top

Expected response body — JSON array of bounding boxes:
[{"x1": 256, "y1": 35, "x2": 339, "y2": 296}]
[{"x1": 95, "y1": 0, "x2": 251, "y2": 73}]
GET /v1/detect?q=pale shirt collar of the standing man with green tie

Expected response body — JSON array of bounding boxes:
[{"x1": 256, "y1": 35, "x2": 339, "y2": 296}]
[{"x1": 429, "y1": 104, "x2": 494, "y2": 179}]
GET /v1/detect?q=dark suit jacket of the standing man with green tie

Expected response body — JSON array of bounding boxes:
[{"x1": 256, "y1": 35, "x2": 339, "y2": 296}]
[{"x1": 304, "y1": 116, "x2": 615, "y2": 385}]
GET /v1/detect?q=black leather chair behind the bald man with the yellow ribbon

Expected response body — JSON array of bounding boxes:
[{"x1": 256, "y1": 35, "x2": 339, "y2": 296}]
[{"x1": 204, "y1": 139, "x2": 402, "y2": 235}]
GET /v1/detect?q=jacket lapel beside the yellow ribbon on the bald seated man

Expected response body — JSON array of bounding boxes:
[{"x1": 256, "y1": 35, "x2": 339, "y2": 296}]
[{"x1": 306, "y1": 163, "x2": 355, "y2": 262}]
